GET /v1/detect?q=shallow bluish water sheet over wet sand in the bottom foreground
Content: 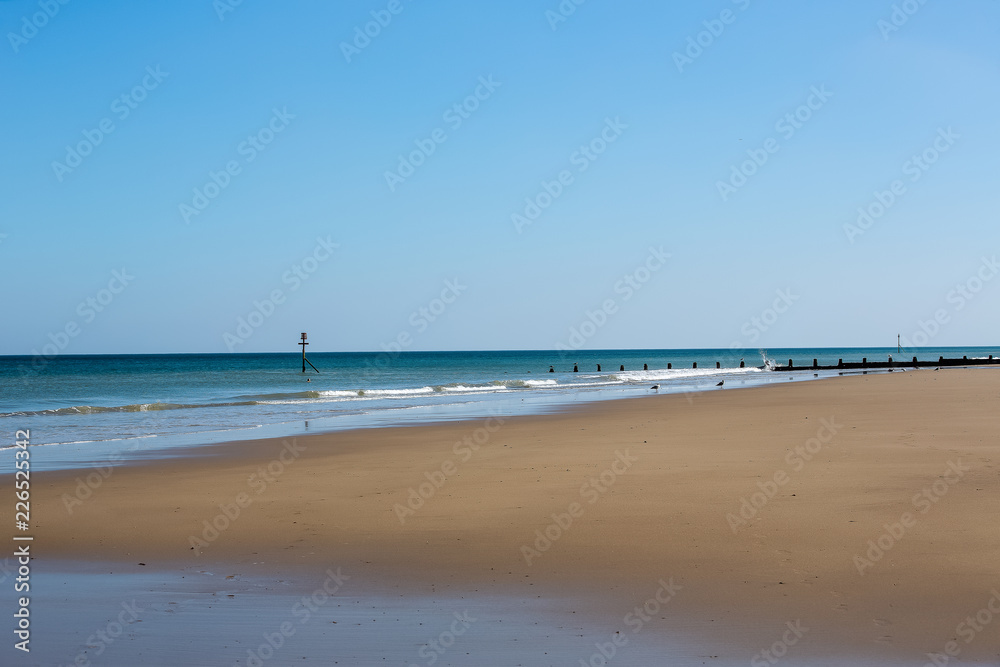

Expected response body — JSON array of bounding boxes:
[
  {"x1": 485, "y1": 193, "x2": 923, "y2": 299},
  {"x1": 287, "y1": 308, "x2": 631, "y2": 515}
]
[{"x1": 0, "y1": 561, "x2": 936, "y2": 667}]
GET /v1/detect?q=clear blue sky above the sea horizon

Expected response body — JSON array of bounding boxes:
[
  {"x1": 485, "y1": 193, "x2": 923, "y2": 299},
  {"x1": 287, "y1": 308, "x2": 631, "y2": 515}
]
[{"x1": 0, "y1": 0, "x2": 1000, "y2": 354}]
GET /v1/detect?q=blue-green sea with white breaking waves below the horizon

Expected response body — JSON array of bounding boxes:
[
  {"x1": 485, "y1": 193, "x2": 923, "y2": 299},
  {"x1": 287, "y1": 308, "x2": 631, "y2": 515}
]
[{"x1": 0, "y1": 347, "x2": 1000, "y2": 472}]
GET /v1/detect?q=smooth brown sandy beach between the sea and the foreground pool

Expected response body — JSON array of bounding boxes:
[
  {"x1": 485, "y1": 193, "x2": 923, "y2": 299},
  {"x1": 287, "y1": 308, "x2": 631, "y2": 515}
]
[{"x1": 9, "y1": 369, "x2": 1000, "y2": 664}]
